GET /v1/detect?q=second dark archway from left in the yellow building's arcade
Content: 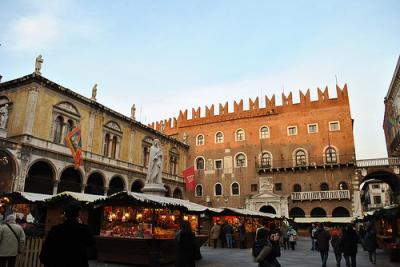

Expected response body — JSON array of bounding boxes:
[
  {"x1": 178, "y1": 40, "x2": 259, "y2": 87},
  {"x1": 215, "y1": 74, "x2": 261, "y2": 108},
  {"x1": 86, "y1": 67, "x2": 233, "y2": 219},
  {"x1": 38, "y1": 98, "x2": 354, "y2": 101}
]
[{"x1": 24, "y1": 160, "x2": 55, "y2": 195}]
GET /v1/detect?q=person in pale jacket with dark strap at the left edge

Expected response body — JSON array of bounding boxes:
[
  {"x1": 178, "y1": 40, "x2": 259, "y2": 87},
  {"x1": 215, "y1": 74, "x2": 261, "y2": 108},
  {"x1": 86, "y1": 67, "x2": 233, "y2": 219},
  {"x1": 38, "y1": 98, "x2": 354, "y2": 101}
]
[{"x1": 0, "y1": 214, "x2": 25, "y2": 267}]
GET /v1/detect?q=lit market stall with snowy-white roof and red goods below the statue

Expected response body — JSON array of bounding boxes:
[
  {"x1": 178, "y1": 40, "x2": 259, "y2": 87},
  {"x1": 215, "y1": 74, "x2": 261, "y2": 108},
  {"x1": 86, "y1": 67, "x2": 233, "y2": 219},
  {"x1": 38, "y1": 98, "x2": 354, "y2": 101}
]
[{"x1": 93, "y1": 192, "x2": 207, "y2": 265}]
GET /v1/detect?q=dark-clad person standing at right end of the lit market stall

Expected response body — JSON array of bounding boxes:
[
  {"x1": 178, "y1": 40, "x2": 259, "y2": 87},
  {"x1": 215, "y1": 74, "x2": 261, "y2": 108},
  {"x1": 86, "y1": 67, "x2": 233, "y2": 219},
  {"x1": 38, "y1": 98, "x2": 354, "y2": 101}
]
[{"x1": 175, "y1": 221, "x2": 196, "y2": 267}]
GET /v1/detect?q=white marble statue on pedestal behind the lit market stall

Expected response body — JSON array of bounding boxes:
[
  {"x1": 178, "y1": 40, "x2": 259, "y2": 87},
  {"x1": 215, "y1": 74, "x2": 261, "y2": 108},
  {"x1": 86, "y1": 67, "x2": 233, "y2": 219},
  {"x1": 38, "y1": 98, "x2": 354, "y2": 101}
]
[{"x1": 146, "y1": 139, "x2": 163, "y2": 184}]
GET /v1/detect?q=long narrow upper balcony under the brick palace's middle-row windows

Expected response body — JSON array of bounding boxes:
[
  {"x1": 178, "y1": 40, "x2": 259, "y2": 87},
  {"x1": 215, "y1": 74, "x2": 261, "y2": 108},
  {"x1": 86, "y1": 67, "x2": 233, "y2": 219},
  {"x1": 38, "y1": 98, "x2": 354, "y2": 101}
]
[{"x1": 256, "y1": 154, "x2": 355, "y2": 173}]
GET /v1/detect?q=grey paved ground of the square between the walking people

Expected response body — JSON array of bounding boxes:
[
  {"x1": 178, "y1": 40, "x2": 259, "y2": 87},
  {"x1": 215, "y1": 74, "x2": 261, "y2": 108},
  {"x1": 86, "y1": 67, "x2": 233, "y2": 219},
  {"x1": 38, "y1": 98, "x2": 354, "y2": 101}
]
[{"x1": 90, "y1": 239, "x2": 400, "y2": 267}]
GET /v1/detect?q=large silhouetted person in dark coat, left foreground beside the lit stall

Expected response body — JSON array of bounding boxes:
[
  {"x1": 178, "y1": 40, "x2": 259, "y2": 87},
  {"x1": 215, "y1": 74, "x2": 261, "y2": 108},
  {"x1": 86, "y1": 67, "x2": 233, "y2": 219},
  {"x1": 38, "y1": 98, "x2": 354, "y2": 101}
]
[{"x1": 40, "y1": 202, "x2": 94, "y2": 267}]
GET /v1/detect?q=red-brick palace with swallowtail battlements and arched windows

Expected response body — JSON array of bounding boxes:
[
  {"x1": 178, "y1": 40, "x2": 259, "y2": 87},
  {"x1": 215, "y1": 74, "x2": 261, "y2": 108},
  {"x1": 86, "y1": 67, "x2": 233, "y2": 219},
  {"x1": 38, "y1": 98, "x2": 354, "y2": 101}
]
[{"x1": 150, "y1": 85, "x2": 355, "y2": 217}]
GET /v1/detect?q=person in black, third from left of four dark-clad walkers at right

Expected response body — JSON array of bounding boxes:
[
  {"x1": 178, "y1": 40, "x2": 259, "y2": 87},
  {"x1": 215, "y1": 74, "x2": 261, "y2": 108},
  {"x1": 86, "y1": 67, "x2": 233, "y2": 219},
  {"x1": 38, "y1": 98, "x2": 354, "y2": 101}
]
[{"x1": 341, "y1": 224, "x2": 358, "y2": 267}]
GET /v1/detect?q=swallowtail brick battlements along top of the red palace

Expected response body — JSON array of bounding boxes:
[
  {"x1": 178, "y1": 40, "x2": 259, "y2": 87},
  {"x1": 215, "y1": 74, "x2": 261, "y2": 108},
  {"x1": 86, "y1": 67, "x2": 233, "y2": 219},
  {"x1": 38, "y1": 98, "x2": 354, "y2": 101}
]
[{"x1": 148, "y1": 84, "x2": 349, "y2": 135}]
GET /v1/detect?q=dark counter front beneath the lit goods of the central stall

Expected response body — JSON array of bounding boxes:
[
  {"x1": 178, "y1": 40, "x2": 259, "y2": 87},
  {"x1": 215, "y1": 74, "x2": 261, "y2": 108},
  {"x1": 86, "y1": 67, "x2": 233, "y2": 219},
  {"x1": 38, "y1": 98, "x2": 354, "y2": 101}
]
[{"x1": 96, "y1": 235, "x2": 208, "y2": 265}]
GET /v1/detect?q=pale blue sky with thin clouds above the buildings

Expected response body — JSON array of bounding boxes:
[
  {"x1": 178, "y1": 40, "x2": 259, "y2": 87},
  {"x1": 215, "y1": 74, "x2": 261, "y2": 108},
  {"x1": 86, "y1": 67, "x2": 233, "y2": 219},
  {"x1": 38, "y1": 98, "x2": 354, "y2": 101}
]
[{"x1": 0, "y1": 0, "x2": 400, "y2": 159}]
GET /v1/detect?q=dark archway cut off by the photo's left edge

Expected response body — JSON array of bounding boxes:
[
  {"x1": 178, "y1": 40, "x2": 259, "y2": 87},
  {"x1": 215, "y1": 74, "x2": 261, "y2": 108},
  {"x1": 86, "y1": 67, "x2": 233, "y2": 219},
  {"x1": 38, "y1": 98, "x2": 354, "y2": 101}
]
[{"x1": 0, "y1": 150, "x2": 17, "y2": 192}]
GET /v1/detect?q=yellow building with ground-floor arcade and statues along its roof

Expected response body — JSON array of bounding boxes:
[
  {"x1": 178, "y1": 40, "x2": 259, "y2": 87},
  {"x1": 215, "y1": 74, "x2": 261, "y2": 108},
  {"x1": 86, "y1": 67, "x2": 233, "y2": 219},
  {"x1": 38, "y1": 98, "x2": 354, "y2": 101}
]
[{"x1": 0, "y1": 73, "x2": 188, "y2": 198}]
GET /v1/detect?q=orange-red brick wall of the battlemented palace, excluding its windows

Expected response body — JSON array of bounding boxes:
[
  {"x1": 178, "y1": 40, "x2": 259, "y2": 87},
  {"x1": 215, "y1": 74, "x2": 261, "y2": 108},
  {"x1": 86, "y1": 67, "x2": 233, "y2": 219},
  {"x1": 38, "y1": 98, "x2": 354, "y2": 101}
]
[{"x1": 152, "y1": 85, "x2": 354, "y2": 218}]
